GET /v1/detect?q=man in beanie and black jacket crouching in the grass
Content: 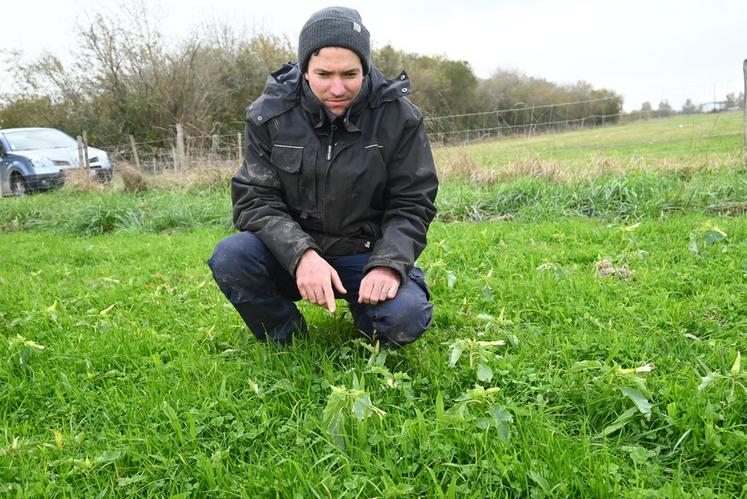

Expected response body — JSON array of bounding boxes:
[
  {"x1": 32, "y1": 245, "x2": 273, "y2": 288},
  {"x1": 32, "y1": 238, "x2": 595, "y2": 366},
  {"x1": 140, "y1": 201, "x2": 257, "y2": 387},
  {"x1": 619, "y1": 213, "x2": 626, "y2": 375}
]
[{"x1": 208, "y1": 7, "x2": 438, "y2": 347}]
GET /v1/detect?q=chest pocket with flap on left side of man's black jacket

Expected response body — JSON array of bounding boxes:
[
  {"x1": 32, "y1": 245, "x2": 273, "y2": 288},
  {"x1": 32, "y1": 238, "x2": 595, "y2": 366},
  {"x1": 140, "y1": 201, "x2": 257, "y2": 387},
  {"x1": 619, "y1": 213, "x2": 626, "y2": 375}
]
[{"x1": 270, "y1": 144, "x2": 314, "y2": 218}]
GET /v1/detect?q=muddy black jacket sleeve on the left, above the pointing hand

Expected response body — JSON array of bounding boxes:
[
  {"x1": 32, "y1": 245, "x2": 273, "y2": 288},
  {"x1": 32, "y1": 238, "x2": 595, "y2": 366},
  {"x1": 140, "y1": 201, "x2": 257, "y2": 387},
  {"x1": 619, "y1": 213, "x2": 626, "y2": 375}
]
[{"x1": 231, "y1": 115, "x2": 321, "y2": 275}]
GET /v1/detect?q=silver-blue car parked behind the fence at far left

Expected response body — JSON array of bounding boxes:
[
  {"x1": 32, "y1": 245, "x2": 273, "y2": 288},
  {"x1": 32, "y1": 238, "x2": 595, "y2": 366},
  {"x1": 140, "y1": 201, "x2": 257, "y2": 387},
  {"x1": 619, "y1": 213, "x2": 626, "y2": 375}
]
[{"x1": 0, "y1": 128, "x2": 112, "y2": 195}]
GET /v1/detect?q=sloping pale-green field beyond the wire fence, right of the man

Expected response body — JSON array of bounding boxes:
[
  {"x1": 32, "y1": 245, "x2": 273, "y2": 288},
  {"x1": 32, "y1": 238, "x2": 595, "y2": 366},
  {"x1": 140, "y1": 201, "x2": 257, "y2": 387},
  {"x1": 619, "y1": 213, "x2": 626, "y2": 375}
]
[{"x1": 436, "y1": 112, "x2": 744, "y2": 183}]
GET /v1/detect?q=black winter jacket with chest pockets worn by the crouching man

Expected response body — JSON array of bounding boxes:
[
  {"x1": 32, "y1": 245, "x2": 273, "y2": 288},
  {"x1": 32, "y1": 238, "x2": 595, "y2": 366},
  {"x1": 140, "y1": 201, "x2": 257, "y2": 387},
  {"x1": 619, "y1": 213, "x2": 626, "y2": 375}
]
[{"x1": 231, "y1": 64, "x2": 438, "y2": 282}]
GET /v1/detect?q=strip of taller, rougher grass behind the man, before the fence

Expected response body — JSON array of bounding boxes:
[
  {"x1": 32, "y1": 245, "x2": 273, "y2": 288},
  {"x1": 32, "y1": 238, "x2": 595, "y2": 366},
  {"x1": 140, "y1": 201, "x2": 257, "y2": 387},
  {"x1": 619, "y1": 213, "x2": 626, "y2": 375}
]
[{"x1": 0, "y1": 167, "x2": 747, "y2": 235}]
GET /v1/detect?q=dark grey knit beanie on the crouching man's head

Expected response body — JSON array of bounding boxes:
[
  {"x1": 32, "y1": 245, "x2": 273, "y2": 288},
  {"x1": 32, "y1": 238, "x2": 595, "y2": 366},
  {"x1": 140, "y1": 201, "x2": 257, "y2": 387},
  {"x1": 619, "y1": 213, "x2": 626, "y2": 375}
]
[{"x1": 298, "y1": 7, "x2": 371, "y2": 75}]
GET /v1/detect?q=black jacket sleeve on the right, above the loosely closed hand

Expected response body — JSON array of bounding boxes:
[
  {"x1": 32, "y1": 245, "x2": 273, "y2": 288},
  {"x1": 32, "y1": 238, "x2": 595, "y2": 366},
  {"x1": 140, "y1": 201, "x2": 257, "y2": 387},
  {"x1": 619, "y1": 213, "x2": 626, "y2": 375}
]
[{"x1": 364, "y1": 113, "x2": 438, "y2": 284}]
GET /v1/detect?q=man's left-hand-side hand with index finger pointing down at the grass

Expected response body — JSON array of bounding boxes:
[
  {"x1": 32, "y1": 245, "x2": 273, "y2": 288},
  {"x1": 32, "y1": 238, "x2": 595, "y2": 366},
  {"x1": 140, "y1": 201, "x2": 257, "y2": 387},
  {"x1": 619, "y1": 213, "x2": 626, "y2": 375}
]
[{"x1": 296, "y1": 249, "x2": 347, "y2": 312}]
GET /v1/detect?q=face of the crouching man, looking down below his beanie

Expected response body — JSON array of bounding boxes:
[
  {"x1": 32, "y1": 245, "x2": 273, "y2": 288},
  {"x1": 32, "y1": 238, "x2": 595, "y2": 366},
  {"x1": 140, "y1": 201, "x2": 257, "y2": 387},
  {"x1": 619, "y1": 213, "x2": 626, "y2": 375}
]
[{"x1": 304, "y1": 47, "x2": 363, "y2": 116}]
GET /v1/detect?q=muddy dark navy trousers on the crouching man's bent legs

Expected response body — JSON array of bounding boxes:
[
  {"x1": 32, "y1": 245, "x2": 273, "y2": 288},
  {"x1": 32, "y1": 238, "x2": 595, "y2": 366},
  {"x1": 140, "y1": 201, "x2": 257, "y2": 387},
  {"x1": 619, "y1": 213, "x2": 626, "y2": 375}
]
[{"x1": 208, "y1": 232, "x2": 433, "y2": 347}]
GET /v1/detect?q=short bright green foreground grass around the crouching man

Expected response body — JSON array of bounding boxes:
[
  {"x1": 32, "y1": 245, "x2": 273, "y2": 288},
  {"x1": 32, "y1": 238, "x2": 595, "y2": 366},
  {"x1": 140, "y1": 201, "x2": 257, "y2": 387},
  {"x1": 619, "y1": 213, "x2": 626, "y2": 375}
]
[{"x1": 0, "y1": 216, "x2": 747, "y2": 496}]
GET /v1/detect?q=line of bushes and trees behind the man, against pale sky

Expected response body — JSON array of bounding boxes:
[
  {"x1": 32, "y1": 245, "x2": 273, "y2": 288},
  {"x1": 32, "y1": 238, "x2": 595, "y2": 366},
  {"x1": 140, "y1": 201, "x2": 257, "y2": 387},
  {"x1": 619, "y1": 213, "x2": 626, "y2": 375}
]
[{"x1": 0, "y1": 4, "x2": 732, "y2": 147}]
